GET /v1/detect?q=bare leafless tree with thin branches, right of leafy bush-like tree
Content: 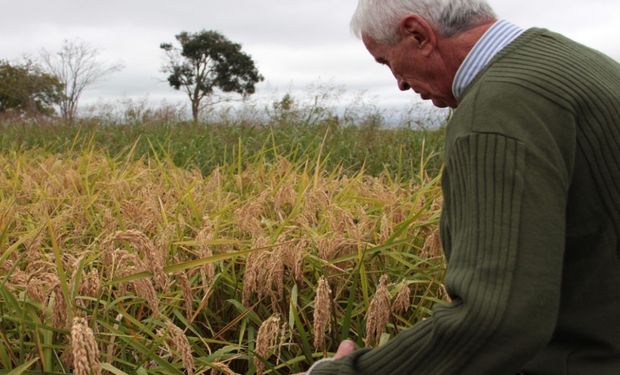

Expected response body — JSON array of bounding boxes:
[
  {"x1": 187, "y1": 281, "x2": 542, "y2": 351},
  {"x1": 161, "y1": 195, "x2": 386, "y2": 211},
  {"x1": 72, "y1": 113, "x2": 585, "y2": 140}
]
[{"x1": 40, "y1": 40, "x2": 123, "y2": 121}]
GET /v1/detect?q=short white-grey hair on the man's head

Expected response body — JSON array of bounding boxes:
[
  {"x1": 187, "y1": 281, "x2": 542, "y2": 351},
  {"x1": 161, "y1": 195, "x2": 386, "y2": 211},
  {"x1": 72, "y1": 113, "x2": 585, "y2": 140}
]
[{"x1": 351, "y1": 0, "x2": 496, "y2": 44}]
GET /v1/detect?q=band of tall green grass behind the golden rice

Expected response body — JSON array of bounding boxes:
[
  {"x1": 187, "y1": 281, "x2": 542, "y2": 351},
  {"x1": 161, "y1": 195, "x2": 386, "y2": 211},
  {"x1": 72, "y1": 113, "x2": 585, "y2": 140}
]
[{"x1": 0, "y1": 118, "x2": 443, "y2": 179}]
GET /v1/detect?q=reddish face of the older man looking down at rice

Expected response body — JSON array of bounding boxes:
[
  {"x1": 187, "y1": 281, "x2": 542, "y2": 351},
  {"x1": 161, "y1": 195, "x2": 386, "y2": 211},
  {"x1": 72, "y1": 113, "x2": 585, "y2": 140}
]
[{"x1": 362, "y1": 36, "x2": 457, "y2": 108}]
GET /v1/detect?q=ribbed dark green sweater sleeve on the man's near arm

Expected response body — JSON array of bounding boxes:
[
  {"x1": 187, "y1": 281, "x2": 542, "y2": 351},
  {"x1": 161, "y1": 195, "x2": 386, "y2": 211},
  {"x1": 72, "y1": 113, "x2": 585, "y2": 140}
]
[{"x1": 311, "y1": 86, "x2": 567, "y2": 375}]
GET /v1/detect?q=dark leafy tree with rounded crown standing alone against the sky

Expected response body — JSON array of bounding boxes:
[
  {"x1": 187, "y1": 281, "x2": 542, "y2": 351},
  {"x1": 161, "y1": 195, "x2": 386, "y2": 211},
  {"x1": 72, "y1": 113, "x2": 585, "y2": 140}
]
[{"x1": 160, "y1": 30, "x2": 263, "y2": 121}]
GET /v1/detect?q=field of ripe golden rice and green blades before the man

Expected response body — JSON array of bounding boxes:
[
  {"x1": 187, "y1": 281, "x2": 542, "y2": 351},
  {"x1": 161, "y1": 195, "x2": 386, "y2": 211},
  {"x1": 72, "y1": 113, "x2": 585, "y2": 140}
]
[{"x1": 0, "y1": 119, "x2": 445, "y2": 374}]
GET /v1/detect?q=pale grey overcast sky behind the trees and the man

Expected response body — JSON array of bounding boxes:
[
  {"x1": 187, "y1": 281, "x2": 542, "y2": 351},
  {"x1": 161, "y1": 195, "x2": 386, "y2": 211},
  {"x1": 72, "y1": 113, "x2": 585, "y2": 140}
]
[{"x1": 0, "y1": 0, "x2": 620, "y2": 116}]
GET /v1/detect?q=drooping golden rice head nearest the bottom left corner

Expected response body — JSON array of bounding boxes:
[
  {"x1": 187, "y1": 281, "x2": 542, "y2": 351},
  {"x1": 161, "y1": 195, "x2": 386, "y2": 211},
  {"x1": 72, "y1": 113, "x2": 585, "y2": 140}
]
[{"x1": 71, "y1": 317, "x2": 101, "y2": 375}]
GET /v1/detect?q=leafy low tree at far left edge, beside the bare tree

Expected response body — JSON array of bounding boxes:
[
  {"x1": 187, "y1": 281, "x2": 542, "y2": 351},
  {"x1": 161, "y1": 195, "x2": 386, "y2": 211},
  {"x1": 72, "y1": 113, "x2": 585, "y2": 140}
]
[{"x1": 0, "y1": 61, "x2": 63, "y2": 115}]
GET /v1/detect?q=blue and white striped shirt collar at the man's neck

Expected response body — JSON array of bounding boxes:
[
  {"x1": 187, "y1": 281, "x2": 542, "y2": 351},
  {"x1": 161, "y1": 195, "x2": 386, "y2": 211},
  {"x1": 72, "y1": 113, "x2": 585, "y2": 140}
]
[{"x1": 452, "y1": 20, "x2": 525, "y2": 100}]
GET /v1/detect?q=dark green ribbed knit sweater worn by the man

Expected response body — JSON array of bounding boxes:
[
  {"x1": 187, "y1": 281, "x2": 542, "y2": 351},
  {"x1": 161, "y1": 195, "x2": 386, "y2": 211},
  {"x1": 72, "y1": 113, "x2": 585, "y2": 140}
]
[{"x1": 311, "y1": 29, "x2": 620, "y2": 375}]
